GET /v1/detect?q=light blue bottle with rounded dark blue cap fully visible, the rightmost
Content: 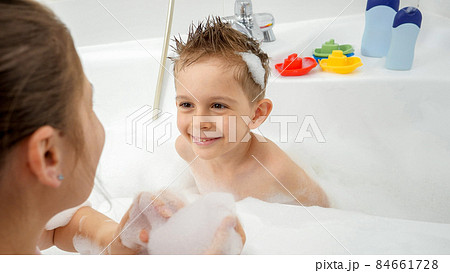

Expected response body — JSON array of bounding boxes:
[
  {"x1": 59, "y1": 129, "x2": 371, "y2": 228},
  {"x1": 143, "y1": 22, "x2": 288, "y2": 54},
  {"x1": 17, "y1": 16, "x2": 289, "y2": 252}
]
[{"x1": 386, "y1": 7, "x2": 422, "y2": 70}]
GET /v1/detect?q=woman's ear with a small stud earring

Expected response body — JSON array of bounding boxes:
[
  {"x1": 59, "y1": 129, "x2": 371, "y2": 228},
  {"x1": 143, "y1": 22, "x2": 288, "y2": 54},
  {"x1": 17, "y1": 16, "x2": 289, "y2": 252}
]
[{"x1": 27, "y1": 126, "x2": 62, "y2": 188}]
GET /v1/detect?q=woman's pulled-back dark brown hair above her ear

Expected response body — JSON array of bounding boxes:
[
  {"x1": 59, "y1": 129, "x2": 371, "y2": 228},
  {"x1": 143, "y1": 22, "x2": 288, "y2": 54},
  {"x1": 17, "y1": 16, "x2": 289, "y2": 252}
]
[{"x1": 0, "y1": 0, "x2": 83, "y2": 170}]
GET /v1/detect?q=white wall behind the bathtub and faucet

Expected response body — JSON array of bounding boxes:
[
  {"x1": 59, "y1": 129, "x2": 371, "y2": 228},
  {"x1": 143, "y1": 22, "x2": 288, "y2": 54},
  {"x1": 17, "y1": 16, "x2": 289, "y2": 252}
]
[{"x1": 40, "y1": 0, "x2": 450, "y2": 46}]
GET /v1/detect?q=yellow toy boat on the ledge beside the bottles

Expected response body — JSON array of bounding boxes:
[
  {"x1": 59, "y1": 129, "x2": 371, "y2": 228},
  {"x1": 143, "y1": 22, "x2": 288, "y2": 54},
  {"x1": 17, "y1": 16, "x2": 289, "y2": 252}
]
[{"x1": 319, "y1": 50, "x2": 362, "y2": 74}]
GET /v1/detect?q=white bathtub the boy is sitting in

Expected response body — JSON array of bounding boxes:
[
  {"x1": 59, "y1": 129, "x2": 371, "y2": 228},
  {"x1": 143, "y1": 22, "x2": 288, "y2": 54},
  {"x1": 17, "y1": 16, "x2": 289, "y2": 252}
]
[{"x1": 43, "y1": 1, "x2": 450, "y2": 254}]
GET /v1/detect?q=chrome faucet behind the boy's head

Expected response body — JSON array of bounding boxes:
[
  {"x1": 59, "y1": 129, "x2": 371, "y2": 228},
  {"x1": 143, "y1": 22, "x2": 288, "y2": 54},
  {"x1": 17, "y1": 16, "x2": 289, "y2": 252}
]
[{"x1": 224, "y1": 0, "x2": 275, "y2": 42}]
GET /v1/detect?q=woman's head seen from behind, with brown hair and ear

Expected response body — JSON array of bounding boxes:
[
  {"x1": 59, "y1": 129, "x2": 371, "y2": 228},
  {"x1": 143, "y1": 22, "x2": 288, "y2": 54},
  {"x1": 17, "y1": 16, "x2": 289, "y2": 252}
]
[{"x1": 0, "y1": 0, "x2": 104, "y2": 212}]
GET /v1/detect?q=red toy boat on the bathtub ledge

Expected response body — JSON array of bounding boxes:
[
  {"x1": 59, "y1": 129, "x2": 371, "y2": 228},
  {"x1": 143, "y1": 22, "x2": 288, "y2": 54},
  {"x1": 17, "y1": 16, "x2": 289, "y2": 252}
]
[{"x1": 275, "y1": 53, "x2": 317, "y2": 76}]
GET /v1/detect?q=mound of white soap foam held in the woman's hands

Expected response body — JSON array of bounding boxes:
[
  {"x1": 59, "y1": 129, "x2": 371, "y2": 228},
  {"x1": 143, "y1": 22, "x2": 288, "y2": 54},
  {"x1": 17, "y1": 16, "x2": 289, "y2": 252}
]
[{"x1": 148, "y1": 193, "x2": 242, "y2": 254}]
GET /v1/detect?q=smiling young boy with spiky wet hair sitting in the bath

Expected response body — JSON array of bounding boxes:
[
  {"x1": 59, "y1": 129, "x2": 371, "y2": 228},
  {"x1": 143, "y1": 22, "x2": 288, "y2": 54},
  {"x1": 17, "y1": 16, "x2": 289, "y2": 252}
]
[{"x1": 172, "y1": 18, "x2": 329, "y2": 207}]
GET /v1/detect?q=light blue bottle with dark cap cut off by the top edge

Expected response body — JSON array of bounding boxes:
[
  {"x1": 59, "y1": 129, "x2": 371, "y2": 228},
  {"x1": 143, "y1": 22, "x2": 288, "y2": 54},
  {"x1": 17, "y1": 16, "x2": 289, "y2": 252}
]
[{"x1": 361, "y1": 0, "x2": 399, "y2": 58}]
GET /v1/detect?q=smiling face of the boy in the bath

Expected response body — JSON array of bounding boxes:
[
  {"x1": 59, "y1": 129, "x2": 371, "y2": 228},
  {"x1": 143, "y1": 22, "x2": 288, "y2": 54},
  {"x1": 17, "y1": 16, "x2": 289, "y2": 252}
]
[{"x1": 175, "y1": 57, "x2": 256, "y2": 160}]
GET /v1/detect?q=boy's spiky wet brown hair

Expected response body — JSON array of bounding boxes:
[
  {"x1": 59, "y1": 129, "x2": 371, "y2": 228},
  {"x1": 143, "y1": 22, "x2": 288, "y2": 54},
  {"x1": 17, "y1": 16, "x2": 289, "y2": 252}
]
[{"x1": 170, "y1": 17, "x2": 270, "y2": 102}]
